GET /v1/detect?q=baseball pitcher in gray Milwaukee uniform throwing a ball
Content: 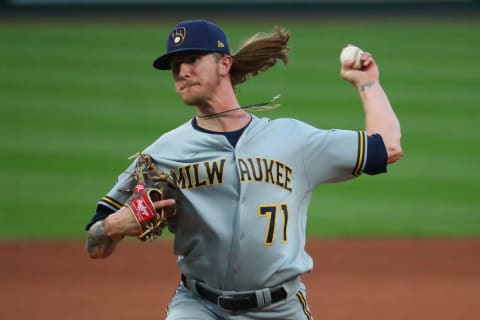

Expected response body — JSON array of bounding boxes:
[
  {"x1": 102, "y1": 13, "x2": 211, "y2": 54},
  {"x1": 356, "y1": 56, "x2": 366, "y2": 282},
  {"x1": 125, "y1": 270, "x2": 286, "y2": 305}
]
[{"x1": 86, "y1": 20, "x2": 402, "y2": 320}]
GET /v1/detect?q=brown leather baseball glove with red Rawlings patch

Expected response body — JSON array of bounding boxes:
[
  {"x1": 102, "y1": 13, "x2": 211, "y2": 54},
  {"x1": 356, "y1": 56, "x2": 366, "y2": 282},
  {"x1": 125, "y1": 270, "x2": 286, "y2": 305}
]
[{"x1": 122, "y1": 153, "x2": 178, "y2": 241}]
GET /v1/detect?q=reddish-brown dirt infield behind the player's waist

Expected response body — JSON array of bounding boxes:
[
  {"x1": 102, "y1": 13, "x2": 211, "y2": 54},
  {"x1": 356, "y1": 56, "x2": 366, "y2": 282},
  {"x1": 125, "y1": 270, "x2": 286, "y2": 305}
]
[{"x1": 0, "y1": 239, "x2": 480, "y2": 320}]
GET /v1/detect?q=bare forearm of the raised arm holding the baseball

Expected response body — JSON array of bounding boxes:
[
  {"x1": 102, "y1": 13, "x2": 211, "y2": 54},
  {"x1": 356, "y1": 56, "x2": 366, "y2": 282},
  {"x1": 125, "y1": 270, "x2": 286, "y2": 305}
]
[{"x1": 357, "y1": 80, "x2": 403, "y2": 163}]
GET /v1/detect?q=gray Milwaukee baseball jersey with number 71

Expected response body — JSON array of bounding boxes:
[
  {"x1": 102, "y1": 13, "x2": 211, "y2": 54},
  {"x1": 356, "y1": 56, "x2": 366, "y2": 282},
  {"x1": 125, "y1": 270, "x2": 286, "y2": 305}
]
[{"x1": 87, "y1": 116, "x2": 386, "y2": 291}]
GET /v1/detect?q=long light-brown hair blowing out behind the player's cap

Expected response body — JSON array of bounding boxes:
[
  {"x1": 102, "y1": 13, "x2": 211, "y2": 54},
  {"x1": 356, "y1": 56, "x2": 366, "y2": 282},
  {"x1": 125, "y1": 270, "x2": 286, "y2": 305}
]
[{"x1": 230, "y1": 27, "x2": 290, "y2": 87}]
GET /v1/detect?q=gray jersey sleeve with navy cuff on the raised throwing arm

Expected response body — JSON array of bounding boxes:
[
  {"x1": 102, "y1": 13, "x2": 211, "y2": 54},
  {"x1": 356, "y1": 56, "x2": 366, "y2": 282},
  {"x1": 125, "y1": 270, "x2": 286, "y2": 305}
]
[{"x1": 304, "y1": 130, "x2": 386, "y2": 186}]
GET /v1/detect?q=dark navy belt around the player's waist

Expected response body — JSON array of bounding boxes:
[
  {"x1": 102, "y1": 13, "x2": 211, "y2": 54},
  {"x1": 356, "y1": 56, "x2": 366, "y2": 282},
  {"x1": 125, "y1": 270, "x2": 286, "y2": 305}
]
[{"x1": 182, "y1": 274, "x2": 287, "y2": 311}]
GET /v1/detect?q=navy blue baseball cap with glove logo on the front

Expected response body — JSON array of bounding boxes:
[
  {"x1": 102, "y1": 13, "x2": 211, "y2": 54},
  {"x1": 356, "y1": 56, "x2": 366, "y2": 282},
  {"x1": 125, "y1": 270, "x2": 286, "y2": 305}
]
[{"x1": 153, "y1": 20, "x2": 230, "y2": 70}]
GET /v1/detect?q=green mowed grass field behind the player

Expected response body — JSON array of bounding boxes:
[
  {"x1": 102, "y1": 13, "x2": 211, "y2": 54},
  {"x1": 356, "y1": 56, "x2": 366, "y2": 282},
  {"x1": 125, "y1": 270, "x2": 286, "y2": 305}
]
[{"x1": 0, "y1": 18, "x2": 480, "y2": 240}]
